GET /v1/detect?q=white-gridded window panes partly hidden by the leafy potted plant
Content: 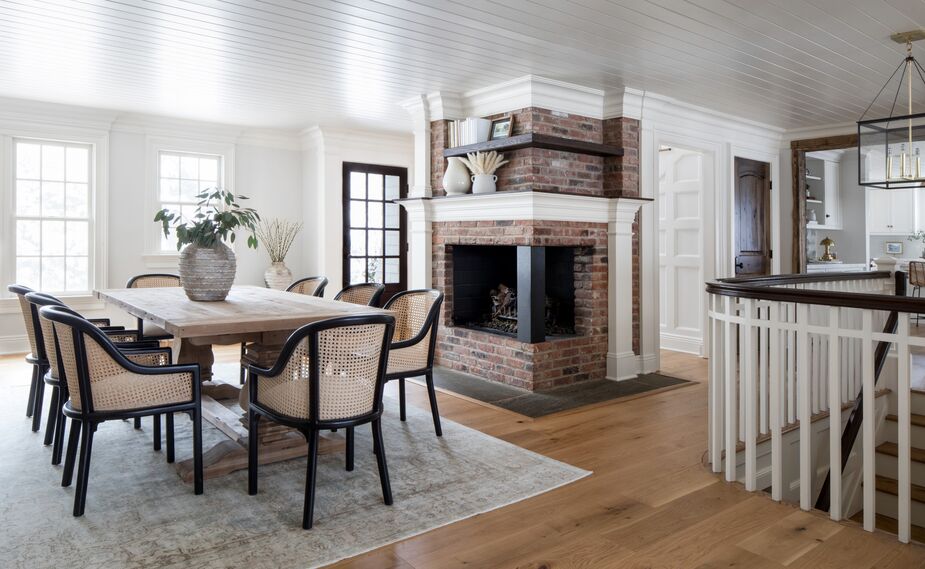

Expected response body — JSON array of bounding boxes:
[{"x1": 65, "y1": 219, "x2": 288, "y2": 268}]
[{"x1": 156, "y1": 150, "x2": 223, "y2": 252}]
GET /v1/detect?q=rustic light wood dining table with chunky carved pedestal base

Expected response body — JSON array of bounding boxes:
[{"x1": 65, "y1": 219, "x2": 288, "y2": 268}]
[{"x1": 94, "y1": 286, "x2": 389, "y2": 482}]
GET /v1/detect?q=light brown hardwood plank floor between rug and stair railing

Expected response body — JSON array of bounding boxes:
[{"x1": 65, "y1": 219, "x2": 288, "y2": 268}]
[{"x1": 0, "y1": 347, "x2": 925, "y2": 569}]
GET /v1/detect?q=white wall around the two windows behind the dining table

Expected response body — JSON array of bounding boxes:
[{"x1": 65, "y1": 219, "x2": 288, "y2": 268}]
[{"x1": 0, "y1": 100, "x2": 304, "y2": 353}]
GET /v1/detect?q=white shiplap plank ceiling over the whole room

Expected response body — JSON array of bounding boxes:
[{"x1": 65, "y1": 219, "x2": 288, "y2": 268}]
[{"x1": 0, "y1": 0, "x2": 925, "y2": 130}]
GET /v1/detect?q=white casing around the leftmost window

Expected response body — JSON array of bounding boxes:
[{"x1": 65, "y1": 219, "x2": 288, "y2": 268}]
[{"x1": 0, "y1": 125, "x2": 109, "y2": 314}]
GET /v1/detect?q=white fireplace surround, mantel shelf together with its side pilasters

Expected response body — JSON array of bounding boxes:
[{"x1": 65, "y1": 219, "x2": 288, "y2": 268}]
[{"x1": 395, "y1": 191, "x2": 652, "y2": 380}]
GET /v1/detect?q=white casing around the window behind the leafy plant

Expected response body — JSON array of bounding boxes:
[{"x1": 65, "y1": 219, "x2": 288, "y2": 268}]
[{"x1": 144, "y1": 137, "x2": 235, "y2": 270}]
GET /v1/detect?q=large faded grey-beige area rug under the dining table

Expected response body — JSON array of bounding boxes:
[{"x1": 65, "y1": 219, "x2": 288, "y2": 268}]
[{"x1": 0, "y1": 382, "x2": 590, "y2": 569}]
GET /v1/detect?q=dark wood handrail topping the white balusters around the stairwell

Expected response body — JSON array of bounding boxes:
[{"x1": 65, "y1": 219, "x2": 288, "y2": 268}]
[{"x1": 706, "y1": 271, "x2": 925, "y2": 314}]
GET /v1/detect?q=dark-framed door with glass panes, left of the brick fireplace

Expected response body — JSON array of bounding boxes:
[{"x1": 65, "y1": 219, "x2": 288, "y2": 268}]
[{"x1": 343, "y1": 163, "x2": 408, "y2": 300}]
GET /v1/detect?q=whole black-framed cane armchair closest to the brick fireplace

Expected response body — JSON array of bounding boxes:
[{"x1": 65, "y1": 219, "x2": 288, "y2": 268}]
[{"x1": 383, "y1": 289, "x2": 443, "y2": 437}]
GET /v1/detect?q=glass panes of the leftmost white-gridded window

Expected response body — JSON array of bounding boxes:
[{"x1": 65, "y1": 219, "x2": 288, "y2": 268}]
[{"x1": 13, "y1": 139, "x2": 93, "y2": 293}]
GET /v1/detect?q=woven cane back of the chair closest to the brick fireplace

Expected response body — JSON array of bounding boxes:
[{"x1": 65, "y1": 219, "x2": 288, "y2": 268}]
[{"x1": 385, "y1": 289, "x2": 443, "y2": 375}]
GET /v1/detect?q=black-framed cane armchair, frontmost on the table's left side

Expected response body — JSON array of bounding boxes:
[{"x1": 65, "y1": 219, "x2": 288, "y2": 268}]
[{"x1": 39, "y1": 306, "x2": 202, "y2": 517}]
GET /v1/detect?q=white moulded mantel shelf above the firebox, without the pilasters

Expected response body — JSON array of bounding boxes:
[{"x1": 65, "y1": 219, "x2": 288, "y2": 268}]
[{"x1": 395, "y1": 191, "x2": 652, "y2": 223}]
